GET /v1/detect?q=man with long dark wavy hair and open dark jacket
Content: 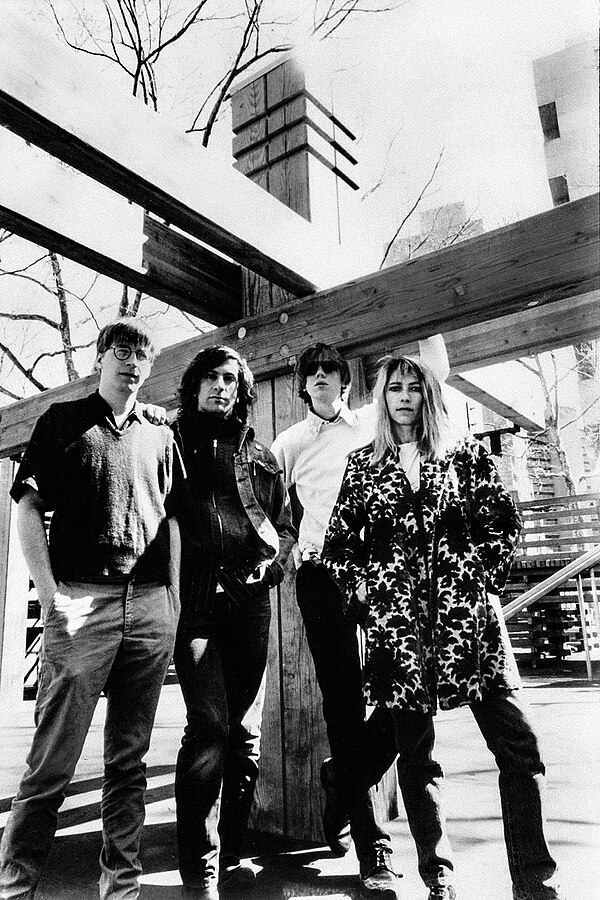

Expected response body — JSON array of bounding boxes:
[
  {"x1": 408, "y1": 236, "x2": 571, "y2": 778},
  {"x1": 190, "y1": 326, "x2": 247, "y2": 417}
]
[{"x1": 174, "y1": 346, "x2": 295, "y2": 900}]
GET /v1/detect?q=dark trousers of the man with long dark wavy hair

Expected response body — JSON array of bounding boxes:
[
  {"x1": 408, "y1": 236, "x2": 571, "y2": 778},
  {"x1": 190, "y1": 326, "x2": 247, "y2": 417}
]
[{"x1": 175, "y1": 586, "x2": 271, "y2": 887}]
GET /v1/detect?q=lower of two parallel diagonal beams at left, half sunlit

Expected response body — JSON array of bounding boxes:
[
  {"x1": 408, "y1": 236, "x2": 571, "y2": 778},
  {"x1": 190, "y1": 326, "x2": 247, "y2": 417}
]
[{"x1": 0, "y1": 139, "x2": 241, "y2": 325}]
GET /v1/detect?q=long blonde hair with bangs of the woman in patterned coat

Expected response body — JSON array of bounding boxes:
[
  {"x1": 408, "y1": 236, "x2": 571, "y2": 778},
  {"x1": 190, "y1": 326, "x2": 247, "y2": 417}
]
[{"x1": 371, "y1": 355, "x2": 448, "y2": 466}]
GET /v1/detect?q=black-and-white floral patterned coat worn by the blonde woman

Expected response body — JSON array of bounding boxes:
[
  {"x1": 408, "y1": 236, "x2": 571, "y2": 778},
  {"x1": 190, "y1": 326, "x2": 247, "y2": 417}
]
[{"x1": 323, "y1": 439, "x2": 521, "y2": 712}]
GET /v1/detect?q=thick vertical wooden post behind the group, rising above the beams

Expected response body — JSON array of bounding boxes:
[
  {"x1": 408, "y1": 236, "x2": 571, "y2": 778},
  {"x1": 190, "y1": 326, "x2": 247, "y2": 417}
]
[{"x1": 232, "y1": 58, "x2": 396, "y2": 842}]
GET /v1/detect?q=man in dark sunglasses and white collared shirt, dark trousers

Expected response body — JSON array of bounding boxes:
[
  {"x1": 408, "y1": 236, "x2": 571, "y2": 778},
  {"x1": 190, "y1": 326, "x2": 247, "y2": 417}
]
[{"x1": 271, "y1": 335, "x2": 449, "y2": 898}]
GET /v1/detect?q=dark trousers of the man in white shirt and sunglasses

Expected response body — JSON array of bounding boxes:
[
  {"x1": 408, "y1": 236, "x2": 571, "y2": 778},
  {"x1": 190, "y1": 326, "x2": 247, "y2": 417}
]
[{"x1": 296, "y1": 562, "x2": 396, "y2": 858}]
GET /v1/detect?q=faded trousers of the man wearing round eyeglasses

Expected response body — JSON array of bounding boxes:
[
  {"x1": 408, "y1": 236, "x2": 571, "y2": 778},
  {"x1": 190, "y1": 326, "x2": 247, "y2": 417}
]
[{"x1": 0, "y1": 582, "x2": 179, "y2": 900}]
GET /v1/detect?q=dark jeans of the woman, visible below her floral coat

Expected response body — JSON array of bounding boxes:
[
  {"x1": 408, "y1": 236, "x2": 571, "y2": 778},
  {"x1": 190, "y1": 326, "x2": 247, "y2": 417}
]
[{"x1": 393, "y1": 691, "x2": 561, "y2": 900}]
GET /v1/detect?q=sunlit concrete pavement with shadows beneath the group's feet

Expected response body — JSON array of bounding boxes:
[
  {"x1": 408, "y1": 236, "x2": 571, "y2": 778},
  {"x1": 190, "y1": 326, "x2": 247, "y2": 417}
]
[{"x1": 0, "y1": 661, "x2": 600, "y2": 900}]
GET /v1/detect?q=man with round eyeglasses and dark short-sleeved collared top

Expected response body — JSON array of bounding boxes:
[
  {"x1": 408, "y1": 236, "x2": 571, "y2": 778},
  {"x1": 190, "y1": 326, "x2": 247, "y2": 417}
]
[{"x1": 0, "y1": 319, "x2": 183, "y2": 900}]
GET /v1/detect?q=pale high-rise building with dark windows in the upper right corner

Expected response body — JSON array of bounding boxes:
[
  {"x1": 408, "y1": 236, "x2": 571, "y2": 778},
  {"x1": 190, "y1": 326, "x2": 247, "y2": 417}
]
[{"x1": 533, "y1": 38, "x2": 598, "y2": 206}]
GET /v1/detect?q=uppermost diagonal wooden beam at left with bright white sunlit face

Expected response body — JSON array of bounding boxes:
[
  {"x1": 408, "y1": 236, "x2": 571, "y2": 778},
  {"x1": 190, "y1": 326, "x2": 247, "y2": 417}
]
[{"x1": 0, "y1": 4, "x2": 356, "y2": 296}]
